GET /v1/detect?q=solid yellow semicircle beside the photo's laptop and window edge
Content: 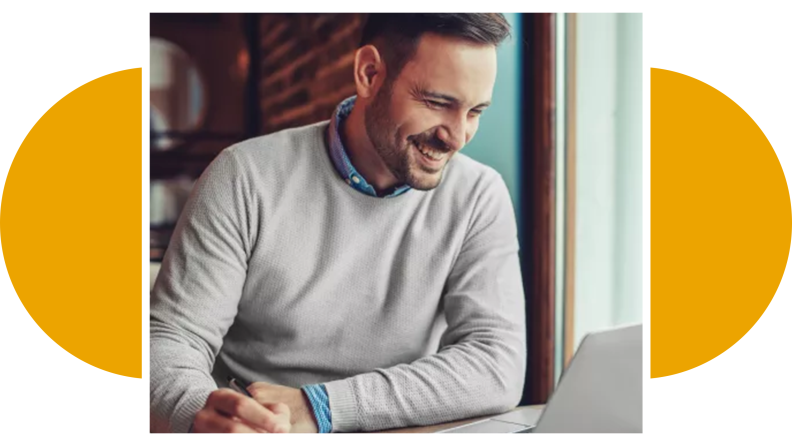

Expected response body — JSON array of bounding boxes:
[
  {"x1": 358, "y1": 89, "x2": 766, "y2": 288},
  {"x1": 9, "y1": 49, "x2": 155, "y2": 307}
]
[{"x1": 651, "y1": 68, "x2": 792, "y2": 378}]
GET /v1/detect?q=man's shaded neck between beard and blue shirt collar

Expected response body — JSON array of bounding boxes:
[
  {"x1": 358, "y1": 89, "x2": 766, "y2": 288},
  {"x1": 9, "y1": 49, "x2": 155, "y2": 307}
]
[{"x1": 339, "y1": 104, "x2": 398, "y2": 195}]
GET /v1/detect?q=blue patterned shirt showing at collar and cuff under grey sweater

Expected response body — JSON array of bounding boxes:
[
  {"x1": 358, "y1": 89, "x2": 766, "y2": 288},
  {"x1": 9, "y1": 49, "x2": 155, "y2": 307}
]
[{"x1": 302, "y1": 96, "x2": 410, "y2": 433}]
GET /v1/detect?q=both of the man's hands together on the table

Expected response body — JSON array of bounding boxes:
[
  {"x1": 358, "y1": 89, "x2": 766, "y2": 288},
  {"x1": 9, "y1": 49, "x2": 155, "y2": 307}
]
[{"x1": 193, "y1": 382, "x2": 318, "y2": 433}]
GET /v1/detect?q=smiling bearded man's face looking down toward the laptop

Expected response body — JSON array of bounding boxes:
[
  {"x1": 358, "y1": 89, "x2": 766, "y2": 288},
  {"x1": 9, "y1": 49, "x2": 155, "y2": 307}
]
[{"x1": 365, "y1": 34, "x2": 496, "y2": 190}]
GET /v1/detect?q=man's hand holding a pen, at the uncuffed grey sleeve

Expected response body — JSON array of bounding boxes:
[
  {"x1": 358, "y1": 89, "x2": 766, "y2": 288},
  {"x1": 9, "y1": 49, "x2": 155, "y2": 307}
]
[{"x1": 193, "y1": 389, "x2": 291, "y2": 433}]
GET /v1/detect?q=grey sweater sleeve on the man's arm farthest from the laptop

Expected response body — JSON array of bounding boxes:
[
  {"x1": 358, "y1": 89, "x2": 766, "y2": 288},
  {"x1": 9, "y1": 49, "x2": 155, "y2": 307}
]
[{"x1": 150, "y1": 148, "x2": 250, "y2": 432}]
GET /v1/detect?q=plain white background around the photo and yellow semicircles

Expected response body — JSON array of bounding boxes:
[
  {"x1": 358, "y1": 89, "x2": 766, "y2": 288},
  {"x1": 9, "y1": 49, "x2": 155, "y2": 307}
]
[{"x1": 0, "y1": 0, "x2": 792, "y2": 444}]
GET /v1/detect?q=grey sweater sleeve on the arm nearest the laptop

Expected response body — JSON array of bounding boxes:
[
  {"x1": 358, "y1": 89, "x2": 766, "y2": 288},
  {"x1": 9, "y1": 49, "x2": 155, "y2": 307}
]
[{"x1": 326, "y1": 175, "x2": 526, "y2": 432}]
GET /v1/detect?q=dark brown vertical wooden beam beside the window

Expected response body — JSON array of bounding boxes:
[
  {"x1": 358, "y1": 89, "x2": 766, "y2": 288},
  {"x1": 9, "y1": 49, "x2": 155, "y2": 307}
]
[{"x1": 521, "y1": 14, "x2": 556, "y2": 404}]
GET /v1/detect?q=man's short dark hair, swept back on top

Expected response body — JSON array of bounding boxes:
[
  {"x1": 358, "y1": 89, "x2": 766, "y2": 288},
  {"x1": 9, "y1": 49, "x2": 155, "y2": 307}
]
[{"x1": 360, "y1": 13, "x2": 511, "y2": 81}]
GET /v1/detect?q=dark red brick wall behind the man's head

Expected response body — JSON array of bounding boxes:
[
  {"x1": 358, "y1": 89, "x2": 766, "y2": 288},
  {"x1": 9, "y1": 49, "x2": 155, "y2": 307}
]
[{"x1": 259, "y1": 14, "x2": 366, "y2": 134}]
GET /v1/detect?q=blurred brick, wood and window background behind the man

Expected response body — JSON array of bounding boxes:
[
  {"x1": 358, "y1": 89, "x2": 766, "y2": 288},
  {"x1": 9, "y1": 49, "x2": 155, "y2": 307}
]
[{"x1": 150, "y1": 13, "x2": 643, "y2": 404}]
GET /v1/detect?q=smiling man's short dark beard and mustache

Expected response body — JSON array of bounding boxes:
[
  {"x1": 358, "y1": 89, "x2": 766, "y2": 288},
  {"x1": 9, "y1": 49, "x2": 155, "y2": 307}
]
[{"x1": 364, "y1": 80, "x2": 450, "y2": 190}]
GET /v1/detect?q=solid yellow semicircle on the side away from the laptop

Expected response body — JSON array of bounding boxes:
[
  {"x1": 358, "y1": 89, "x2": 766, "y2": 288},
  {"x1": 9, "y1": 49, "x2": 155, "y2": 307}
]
[{"x1": 0, "y1": 68, "x2": 142, "y2": 378}]
